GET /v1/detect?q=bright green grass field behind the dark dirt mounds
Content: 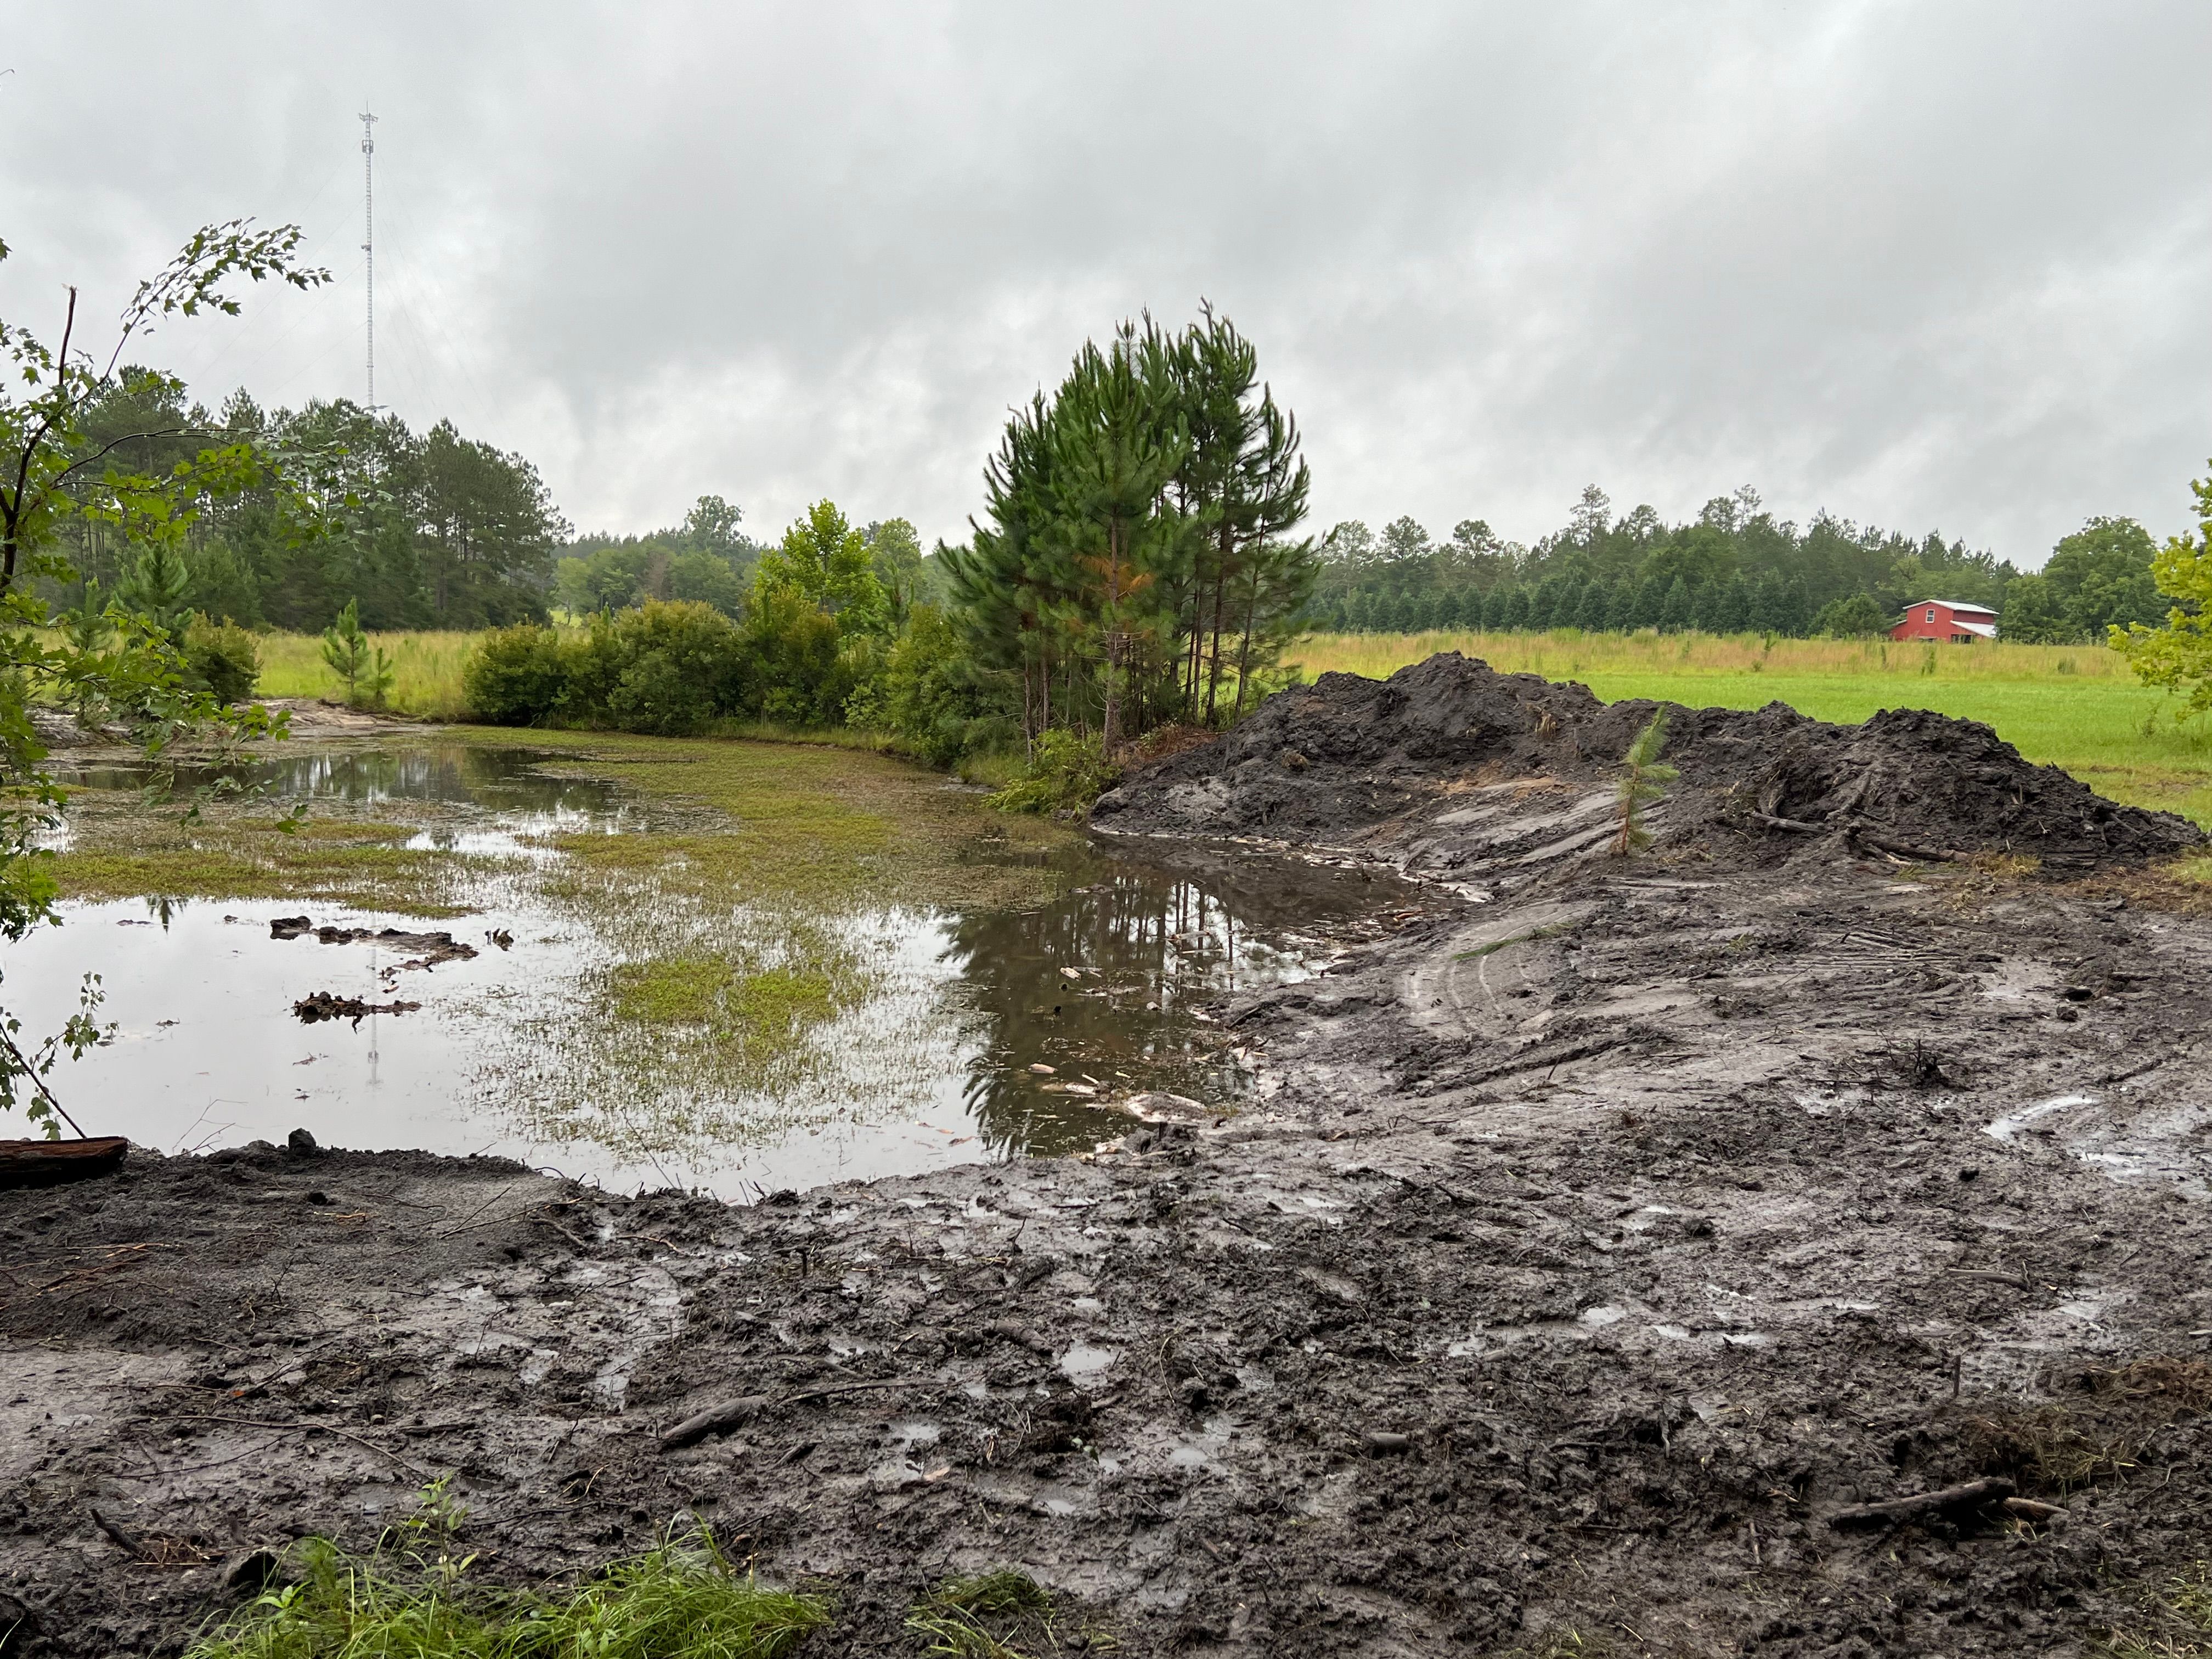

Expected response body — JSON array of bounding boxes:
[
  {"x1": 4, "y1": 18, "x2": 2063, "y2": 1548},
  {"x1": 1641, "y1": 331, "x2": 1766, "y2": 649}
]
[{"x1": 1292, "y1": 630, "x2": 2212, "y2": 827}]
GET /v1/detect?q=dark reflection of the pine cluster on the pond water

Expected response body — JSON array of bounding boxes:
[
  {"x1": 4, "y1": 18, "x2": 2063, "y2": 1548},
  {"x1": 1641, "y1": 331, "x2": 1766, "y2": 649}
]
[{"x1": 945, "y1": 849, "x2": 1409, "y2": 1155}]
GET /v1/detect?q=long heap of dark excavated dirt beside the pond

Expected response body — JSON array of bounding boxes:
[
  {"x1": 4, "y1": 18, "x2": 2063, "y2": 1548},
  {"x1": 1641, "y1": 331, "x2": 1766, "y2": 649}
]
[{"x1": 1093, "y1": 652, "x2": 2205, "y2": 870}]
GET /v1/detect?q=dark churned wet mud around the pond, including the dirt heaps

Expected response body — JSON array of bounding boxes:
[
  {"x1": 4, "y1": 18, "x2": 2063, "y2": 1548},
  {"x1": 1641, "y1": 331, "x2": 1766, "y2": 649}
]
[{"x1": 0, "y1": 654, "x2": 2212, "y2": 1657}]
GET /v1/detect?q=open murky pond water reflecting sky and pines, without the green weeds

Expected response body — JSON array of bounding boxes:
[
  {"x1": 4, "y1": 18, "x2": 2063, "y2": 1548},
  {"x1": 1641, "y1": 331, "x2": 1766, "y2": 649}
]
[{"x1": 13, "y1": 746, "x2": 1404, "y2": 1197}]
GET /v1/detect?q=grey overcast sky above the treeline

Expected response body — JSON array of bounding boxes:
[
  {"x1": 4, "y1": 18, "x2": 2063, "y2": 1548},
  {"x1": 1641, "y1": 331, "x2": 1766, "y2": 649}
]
[{"x1": 0, "y1": 0, "x2": 2212, "y2": 564}]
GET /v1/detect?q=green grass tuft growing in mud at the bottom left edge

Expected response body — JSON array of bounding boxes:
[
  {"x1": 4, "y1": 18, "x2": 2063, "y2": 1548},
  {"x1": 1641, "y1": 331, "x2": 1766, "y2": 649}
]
[{"x1": 188, "y1": 1482, "x2": 830, "y2": 1659}]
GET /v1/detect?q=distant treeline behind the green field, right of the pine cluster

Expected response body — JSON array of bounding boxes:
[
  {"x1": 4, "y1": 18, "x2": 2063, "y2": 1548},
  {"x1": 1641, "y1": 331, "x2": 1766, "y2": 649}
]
[{"x1": 1314, "y1": 484, "x2": 2165, "y2": 641}]
